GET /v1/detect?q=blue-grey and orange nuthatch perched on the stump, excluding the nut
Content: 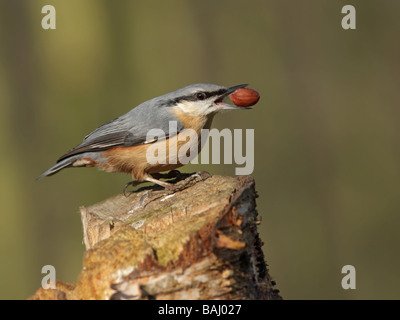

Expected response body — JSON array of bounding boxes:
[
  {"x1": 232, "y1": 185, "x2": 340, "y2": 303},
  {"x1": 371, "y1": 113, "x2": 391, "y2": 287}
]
[{"x1": 38, "y1": 83, "x2": 247, "y2": 191}]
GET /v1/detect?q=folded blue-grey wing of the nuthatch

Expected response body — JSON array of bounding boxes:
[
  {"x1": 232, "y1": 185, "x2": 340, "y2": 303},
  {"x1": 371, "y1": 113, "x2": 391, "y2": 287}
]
[{"x1": 57, "y1": 106, "x2": 184, "y2": 162}]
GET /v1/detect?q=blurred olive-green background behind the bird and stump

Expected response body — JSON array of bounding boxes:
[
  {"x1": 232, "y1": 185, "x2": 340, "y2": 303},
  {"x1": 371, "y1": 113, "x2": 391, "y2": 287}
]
[{"x1": 0, "y1": 0, "x2": 400, "y2": 299}]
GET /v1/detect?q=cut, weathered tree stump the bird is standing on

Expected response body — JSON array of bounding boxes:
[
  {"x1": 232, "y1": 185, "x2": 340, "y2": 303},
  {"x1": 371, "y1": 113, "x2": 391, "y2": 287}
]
[{"x1": 30, "y1": 176, "x2": 281, "y2": 299}]
